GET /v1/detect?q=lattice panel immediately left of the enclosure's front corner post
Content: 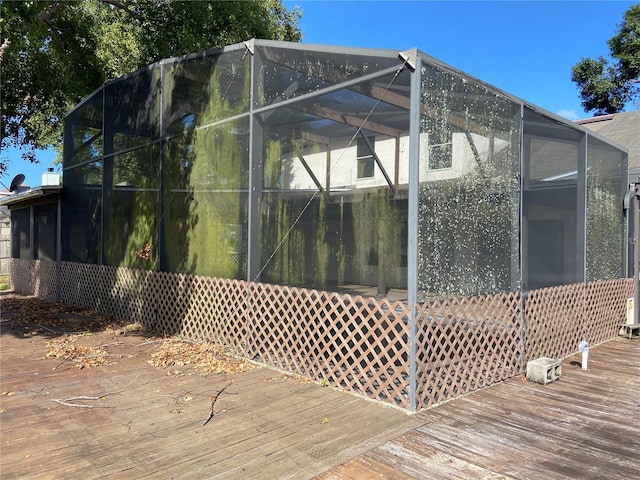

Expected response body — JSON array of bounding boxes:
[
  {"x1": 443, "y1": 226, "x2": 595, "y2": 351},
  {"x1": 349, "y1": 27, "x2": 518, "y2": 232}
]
[{"x1": 245, "y1": 284, "x2": 410, "y2": 407}]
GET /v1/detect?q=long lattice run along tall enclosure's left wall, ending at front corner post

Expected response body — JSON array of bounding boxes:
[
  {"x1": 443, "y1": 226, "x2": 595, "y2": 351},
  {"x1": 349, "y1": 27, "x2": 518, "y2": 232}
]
[{"x1": 57, "y1": 263, "x2": 409, "y2": 407}]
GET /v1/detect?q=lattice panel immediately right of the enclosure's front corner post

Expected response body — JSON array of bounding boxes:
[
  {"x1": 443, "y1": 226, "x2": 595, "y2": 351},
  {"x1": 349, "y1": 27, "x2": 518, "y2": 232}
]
[{"x1": 416, "y1": 293, "x2": 524, "y2": 409}]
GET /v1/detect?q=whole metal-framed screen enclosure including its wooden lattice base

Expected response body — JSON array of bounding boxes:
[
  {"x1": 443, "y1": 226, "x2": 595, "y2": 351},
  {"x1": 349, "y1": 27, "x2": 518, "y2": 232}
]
[{"x1": 25, "y1": 40, "x2": 633, "y2": 410}]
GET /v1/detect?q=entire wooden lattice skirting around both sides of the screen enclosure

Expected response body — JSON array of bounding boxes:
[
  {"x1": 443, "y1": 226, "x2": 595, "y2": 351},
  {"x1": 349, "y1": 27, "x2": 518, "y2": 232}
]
[{"x1": 11, "y1": 259, "x2": 633, "y2": 410}]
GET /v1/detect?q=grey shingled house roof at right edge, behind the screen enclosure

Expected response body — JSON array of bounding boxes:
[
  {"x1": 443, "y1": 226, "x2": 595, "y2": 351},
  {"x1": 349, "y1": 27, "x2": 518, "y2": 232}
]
[{"x1": 576, "y1": 110, "x2": 640, "y2": 183}]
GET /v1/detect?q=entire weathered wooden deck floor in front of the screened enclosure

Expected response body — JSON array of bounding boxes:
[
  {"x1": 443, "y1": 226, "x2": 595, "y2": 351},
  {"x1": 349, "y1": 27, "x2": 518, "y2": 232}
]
[{"x1": 0, "y1": 298, "x2": 640, "y2": 480}]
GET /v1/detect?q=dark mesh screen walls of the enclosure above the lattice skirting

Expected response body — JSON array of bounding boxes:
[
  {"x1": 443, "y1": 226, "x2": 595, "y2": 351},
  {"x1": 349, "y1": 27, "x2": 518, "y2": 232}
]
[{"x1": 63, "y1": 41, "x2": 626, "y2": 299}]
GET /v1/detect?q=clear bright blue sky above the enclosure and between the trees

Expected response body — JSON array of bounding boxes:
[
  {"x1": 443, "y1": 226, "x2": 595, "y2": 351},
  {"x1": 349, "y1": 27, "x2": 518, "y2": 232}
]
[{"x1": 0, "y1": 0, "x2": 638, "y2": 186}]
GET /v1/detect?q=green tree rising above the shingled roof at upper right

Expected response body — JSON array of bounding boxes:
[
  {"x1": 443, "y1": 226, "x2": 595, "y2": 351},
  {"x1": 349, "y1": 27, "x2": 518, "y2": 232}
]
[{"x1": 571, "y1": 4, "x2": 640, "y2": 115}]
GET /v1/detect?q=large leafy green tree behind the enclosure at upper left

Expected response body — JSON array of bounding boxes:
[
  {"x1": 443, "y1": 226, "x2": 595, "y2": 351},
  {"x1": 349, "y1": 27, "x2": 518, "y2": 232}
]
[{"x1": 0, "y1": 0, "x2": 302, "y2": 174}]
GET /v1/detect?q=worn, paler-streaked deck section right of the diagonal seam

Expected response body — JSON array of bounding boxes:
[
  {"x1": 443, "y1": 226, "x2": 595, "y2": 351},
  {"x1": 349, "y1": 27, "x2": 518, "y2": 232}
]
[{"x1": 317, "y1": 338, "x2": 640, "y2": 480}]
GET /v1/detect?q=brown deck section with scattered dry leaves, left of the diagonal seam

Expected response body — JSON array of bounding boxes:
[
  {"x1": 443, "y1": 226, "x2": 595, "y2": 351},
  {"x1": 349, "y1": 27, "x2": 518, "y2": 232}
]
[{"x1": 0, "y1": 298, "x2": 421, "y2": 480}]
